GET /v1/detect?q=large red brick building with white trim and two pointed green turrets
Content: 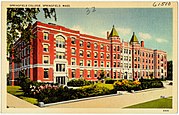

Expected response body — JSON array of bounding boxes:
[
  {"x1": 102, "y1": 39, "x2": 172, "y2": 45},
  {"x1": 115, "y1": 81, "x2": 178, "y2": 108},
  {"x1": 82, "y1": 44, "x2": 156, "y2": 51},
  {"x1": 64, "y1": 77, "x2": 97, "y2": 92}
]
[{"x1": 9, "y1": 22, "x2": 167, "y2": 85}]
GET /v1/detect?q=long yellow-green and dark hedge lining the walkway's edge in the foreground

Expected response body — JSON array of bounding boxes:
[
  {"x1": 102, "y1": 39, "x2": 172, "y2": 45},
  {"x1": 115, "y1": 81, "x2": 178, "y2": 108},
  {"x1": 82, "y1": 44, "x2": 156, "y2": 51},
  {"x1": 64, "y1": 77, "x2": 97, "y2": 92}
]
[{"x1": 35, "y1": 85, "x2": 116, "y2": 103}]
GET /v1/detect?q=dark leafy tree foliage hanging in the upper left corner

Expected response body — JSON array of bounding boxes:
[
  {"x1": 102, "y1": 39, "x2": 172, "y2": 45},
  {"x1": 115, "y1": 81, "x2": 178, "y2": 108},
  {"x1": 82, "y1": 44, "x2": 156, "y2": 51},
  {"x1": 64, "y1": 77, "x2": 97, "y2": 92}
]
[{"x1": 7, "y1": 8, "x2": 57, "y2": 56}]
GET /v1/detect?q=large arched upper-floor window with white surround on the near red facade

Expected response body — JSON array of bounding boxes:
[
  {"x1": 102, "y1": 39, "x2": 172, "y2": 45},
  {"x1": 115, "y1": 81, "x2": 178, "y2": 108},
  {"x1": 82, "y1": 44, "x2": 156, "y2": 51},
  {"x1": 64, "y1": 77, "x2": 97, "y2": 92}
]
[{"x1": 56, "y1": 35, "x2": 65, "y2": 48}]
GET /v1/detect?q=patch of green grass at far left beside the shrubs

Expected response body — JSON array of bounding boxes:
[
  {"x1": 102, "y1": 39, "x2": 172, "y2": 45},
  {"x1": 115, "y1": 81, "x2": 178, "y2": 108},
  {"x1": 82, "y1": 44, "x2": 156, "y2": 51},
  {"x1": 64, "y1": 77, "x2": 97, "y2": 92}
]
[{"x1": 7, "y1": 86, "x2": 38, "y2": 105}]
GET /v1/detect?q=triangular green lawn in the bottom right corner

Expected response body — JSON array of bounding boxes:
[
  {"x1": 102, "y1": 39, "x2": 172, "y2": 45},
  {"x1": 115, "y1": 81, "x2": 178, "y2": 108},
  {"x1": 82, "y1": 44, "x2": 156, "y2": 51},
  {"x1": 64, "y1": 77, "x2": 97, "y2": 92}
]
[{"x1": 125, "y1": 97, "x2": 172, "y2": 108}]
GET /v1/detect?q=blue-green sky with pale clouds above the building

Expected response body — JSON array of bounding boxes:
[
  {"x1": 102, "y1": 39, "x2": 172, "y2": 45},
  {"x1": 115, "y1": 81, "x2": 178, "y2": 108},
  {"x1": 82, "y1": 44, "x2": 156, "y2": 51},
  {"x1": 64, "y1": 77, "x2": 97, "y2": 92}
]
[{"x1": 38, "y1": 8, "x2": 173, "y2": 60}]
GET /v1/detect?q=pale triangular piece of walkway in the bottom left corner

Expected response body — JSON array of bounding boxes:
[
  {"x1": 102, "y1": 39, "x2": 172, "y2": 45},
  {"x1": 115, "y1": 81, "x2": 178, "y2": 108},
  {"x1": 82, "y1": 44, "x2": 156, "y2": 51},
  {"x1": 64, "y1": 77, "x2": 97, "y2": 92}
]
[{"x1": 7, "y1": 93, "x2": 38, "y2": 108}]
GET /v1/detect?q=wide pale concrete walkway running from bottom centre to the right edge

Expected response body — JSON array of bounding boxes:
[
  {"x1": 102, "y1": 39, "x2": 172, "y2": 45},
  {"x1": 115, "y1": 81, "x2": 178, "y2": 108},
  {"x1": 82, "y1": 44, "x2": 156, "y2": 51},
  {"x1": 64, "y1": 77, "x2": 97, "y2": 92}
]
[{"x1": 47, "y1": 82, "x2": 172, "y2": 108}]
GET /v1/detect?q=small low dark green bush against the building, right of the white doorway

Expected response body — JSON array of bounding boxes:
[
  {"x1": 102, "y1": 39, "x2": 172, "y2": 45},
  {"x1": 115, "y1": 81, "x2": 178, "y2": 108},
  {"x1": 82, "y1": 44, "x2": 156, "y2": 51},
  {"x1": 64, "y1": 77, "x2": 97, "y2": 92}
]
[{"x1": 67, "y1": 79, "x2": 94, "y2": 87}]
